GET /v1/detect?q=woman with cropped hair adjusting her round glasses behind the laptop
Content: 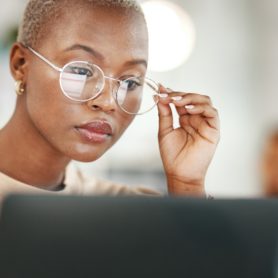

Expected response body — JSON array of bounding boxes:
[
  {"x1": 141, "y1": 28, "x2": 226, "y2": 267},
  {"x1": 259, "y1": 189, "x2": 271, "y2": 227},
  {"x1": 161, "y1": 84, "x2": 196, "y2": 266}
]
[{"x1": 0, "y1": 0, "x2": 219, "y2": 201}]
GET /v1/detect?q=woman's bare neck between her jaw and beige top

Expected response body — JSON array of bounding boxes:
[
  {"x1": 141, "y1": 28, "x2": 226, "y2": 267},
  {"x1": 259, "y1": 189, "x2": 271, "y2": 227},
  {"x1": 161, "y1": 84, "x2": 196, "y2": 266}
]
[{"x1": 0, "y1": 103, "x2": 70, "y2": 190}]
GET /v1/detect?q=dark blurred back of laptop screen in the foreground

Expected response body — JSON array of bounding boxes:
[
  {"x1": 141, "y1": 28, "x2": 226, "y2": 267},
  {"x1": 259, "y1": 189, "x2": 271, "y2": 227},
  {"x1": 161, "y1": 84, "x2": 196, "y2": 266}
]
[{"x1": 0, "y1": 195, "x2": 278, "y2": 278}]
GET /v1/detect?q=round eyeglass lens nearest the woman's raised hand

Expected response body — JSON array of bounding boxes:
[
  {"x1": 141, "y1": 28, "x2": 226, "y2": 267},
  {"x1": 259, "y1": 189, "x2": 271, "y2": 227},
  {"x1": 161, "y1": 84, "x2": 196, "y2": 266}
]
[{"x1": 117, "y1": 77, "x2": 159, "y2": 115}]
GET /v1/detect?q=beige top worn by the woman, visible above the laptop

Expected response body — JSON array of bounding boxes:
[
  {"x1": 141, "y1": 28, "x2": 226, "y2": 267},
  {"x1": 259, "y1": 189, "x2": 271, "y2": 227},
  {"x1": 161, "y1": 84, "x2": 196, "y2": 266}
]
[{"x1": 0, "y1": 164, "x2": 162, "y2": 204}]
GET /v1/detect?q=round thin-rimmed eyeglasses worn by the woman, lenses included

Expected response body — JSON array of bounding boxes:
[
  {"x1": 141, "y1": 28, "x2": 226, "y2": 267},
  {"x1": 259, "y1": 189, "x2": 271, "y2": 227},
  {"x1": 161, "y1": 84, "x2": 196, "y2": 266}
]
[{"x1": 27, "y1": 46, "x2": 159, "y2": 115}]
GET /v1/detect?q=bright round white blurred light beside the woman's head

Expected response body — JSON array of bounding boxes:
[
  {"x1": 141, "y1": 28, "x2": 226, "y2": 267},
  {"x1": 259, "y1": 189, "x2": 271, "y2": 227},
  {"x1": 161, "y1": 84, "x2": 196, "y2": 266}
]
[{"x1": 142, "y1": 0, "x2": 195, "y2": 72}]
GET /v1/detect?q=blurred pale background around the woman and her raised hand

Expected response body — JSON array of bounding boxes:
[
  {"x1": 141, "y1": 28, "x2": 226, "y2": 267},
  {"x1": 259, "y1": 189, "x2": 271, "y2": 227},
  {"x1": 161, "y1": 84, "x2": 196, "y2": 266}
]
[{"x1": 0, "y1": 0, "x2": 278, "y2": 197}]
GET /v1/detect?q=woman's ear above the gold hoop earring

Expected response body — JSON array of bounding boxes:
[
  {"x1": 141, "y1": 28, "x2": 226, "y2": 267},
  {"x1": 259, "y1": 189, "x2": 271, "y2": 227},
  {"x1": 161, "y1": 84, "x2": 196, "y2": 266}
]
[{"x1": 10, "y1": 43, "x2": 28, "y2": 84}]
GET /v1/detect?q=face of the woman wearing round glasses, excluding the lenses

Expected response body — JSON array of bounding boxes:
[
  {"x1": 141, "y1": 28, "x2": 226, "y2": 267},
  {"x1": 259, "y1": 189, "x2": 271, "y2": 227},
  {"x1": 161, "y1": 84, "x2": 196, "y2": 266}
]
[{"x1": 23, "y1": 7, "x2": 148, "y2": 162}]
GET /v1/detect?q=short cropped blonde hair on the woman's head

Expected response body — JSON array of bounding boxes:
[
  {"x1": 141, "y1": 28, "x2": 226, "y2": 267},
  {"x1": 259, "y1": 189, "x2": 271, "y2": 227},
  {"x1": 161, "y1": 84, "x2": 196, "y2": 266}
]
[{"x1": 17, "y1": 0, "x2": 144, "y2": 47}]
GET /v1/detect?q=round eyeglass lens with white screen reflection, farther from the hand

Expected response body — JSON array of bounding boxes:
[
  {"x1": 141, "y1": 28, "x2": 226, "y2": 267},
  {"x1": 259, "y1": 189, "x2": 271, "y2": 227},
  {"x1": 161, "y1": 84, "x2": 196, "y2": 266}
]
[{"x1": 60, "y1": 62, "x2": 104, "y2": 101}]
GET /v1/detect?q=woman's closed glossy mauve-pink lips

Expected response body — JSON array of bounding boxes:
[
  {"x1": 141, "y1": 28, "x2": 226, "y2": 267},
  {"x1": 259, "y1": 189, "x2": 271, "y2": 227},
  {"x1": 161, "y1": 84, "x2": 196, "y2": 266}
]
[{"x1": 76, "y1": 120, "x2": 113, "y2": 143}]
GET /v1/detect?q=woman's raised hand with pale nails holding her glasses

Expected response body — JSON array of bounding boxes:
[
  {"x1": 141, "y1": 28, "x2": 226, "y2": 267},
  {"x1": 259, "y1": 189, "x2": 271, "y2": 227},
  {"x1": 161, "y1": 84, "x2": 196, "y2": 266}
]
[{"x1": 158, "y1": 86, "x2": 220, "y2": 196}]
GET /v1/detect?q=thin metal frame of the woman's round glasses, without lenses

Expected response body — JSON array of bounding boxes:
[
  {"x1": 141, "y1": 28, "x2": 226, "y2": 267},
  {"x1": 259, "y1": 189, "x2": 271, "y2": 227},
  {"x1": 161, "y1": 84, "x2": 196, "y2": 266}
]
[{"x1": 25, "y1": 46, "x2": 160, "y2": 115}]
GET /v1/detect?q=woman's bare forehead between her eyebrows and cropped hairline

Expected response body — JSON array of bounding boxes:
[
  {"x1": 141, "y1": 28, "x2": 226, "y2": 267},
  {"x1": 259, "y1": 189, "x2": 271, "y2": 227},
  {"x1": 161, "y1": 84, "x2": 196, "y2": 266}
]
[{"x1": 39, "y1": 7, "x2": 148, "y2": 65}]
